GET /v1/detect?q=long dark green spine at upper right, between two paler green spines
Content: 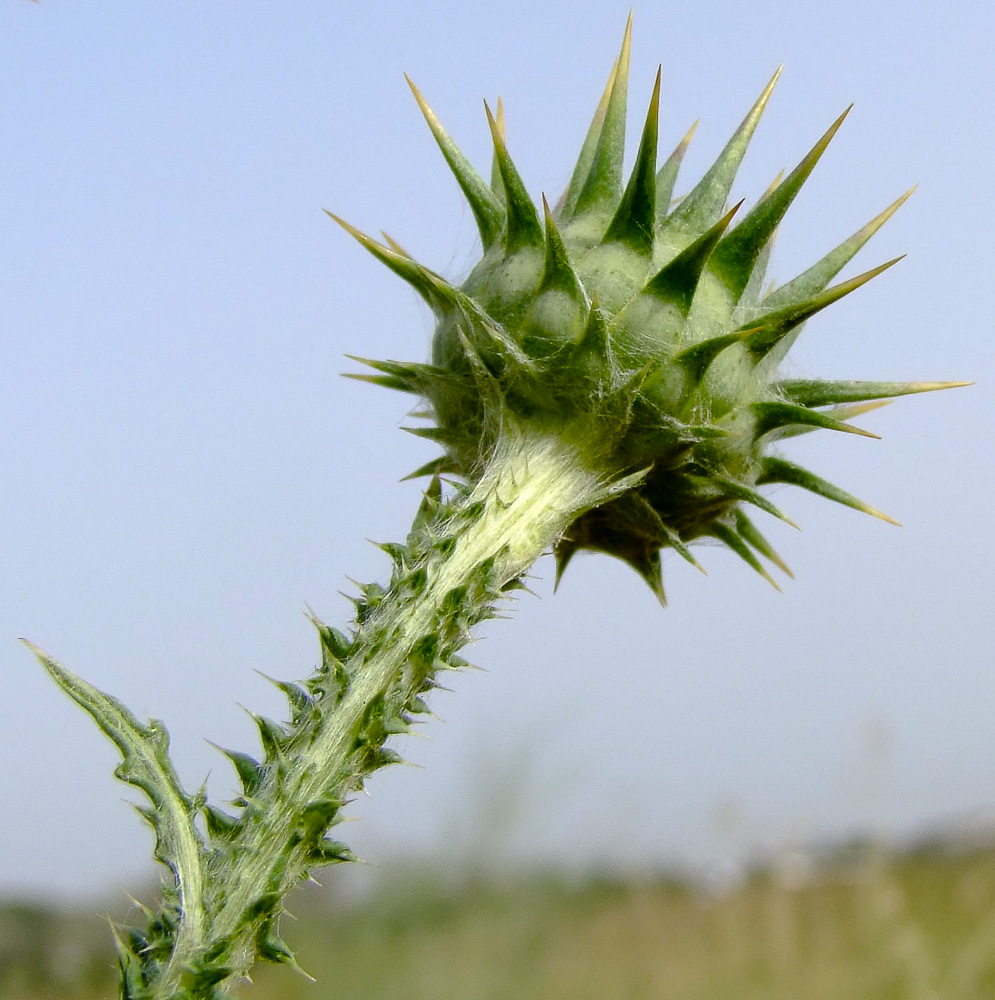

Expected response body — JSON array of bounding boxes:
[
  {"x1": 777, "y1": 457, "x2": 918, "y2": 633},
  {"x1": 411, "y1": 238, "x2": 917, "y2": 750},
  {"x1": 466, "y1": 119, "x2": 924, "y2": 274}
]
[{"x1": 710, "y1": 108, "x2": 850, "y2": 300}]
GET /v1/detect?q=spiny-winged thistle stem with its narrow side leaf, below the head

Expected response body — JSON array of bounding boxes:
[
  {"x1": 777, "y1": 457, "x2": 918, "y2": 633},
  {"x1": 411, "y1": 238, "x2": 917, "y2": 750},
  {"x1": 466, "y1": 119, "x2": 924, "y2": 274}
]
[{"x1": 36, "y1": 418, "x2": 620, "y2": 1000}]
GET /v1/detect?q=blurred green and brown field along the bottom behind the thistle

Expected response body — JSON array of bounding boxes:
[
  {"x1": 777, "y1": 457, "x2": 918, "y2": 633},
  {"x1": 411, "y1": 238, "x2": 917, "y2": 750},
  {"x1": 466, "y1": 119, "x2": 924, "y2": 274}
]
[{"x1": 0, "y1": 845, "x2": 995, "y2": 1000}]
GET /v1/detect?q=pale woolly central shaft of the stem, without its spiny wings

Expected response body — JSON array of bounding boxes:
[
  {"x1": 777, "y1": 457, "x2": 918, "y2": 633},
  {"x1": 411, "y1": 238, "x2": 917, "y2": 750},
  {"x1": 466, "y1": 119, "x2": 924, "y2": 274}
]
[{"x1": 169, "y1": 427, "x2": 614, "y2": 996}]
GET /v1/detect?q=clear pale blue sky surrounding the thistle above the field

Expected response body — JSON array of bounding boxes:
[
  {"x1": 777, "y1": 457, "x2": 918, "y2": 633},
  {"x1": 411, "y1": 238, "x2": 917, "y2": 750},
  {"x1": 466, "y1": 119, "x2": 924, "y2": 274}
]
[{"x1": 0, "y1": 0, "x2": 995, "y2": 893}]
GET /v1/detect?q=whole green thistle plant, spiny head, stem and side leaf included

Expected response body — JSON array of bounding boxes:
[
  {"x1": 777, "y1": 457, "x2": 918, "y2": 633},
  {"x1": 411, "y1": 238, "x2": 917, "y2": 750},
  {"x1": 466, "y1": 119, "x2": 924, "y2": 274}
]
[{"x1": 29, "y1": 17, "x2": 964, "y2": 1000}]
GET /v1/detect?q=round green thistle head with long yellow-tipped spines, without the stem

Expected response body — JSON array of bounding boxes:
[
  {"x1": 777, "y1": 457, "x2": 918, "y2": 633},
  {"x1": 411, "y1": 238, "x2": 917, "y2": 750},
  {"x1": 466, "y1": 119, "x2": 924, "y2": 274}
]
[{"x1": 337, "y1": 18, "x2": 964, "y2": 600}]
